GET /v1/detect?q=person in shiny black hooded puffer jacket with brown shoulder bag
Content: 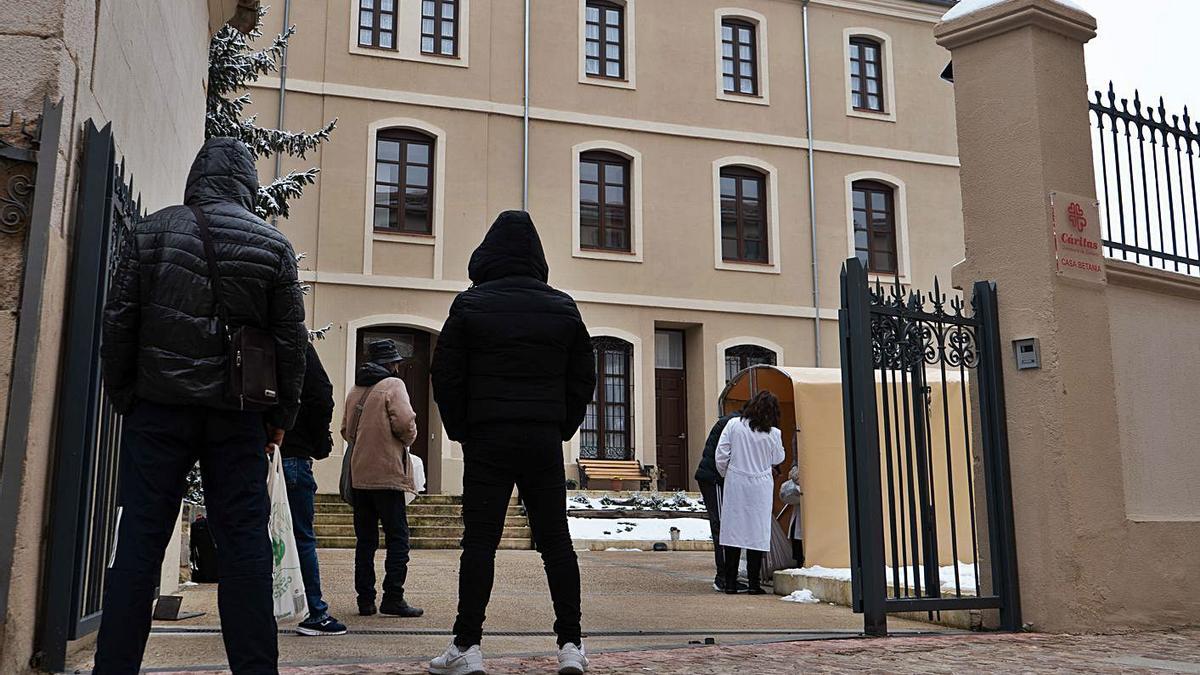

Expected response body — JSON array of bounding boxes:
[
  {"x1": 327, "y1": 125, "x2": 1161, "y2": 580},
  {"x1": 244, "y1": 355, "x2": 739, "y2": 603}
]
[{"x1": 95, "y1": 133, "x2": 308, "y2": 675}]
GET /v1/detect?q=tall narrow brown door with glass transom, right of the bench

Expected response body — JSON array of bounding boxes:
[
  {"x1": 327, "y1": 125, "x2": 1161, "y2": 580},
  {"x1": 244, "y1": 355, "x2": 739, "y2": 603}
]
[{"x1": 654, "y1": 330, "x2": 688, "y2": 490}]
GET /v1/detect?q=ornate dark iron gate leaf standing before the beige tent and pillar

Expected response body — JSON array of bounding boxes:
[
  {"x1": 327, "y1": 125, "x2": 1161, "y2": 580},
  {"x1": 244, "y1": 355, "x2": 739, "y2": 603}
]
[{"x1": 839, "y1": 258, "x2": 1021, "y2": 635}]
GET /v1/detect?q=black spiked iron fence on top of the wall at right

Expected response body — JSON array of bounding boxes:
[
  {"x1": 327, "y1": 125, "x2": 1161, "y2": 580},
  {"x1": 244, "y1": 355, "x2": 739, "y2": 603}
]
[{"x1": 1088, "y1": 83, "x2": 1200, "y2": 275}]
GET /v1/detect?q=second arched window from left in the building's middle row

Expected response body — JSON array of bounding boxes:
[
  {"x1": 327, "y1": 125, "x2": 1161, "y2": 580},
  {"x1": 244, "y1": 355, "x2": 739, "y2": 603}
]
[{"x1": 580, "y1": 150, "x2": 632, "y2": 252}]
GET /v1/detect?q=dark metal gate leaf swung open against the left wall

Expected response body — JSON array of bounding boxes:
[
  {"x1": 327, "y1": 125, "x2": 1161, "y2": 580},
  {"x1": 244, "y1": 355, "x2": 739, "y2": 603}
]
[{"x1": 37, "y1": 121, "x2": 142, "y2": 671}]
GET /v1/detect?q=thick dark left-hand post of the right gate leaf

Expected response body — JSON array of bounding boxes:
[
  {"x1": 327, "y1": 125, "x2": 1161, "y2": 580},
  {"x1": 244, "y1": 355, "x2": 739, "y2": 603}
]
[{"x1": 838, "y1": 258, "x2": 888, "y2": 637}]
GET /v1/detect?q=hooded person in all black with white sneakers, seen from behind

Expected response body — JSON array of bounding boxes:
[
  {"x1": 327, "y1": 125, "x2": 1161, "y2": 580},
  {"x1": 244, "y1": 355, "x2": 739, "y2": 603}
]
[{"x1": 430, "y1": 211, "x2": 596, "y2": 675}]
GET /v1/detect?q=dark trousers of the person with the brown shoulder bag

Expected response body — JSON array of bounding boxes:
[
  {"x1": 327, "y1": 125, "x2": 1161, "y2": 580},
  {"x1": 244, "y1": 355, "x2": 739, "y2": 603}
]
[{"x1": 95, "y1": 401, "x2": 278, "y2": 675}]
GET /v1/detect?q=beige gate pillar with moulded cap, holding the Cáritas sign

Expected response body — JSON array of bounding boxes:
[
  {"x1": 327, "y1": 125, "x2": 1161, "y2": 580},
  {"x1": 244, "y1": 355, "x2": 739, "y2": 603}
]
[{"x1": 935, "y1": 0, "x2": 1133, "y2": 632}]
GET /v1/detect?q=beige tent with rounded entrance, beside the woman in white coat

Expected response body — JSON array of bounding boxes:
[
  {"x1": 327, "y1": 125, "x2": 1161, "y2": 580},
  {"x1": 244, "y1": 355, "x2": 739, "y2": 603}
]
[{"x1": 720, "y1": 365, "x2": 983, "y2": 568}]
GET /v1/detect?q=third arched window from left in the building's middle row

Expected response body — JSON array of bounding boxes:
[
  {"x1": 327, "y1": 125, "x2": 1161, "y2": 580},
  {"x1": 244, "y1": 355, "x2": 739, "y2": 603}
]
[{"x1": 721, "y1": 166, "x2": 770, "y2": 263}]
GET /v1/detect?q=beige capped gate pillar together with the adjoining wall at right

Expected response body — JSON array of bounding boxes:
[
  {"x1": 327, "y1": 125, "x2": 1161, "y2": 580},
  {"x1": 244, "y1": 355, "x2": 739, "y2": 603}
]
[{"x1": 937, "y1": 0, "x2": 1200, "y2": 632}]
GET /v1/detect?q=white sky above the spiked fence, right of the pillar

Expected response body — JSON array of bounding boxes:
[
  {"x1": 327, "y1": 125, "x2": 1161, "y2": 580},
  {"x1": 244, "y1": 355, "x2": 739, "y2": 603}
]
[{"x1": 1075, "y1": 0, "x2": 1200, "y2": 112}]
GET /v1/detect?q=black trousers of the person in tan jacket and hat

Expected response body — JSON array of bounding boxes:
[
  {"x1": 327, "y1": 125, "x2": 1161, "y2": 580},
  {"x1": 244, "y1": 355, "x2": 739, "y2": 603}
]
[{"x1": 354, "y1": 489, "x2": 409, "y2": 604}]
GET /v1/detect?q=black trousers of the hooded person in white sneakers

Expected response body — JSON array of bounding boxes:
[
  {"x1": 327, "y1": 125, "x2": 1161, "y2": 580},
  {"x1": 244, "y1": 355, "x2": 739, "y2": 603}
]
[{"x1": 454, "y1": 425, "x2": 582, "y2": 647}]
